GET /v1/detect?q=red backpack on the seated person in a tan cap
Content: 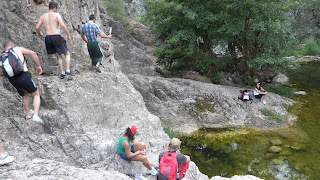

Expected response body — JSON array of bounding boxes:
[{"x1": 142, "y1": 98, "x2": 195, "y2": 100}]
[{"x1": 158, "y1": 151, "x2": 179, "y2": 180}]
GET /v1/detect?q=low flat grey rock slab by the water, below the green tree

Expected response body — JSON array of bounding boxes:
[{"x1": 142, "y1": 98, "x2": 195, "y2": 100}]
[{"x1": 128, "y1": 74, "x2": 294, "y2": 133}]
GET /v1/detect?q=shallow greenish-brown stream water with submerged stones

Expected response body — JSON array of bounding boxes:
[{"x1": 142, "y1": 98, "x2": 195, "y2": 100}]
[{"x1": 181, "y1": 62, "x2": 320, "y2": 180}]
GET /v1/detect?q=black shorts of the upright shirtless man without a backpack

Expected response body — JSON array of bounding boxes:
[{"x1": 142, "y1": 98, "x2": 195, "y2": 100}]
[{"x1": 45, "y1": 35, "x2": 68, "y2": 55}]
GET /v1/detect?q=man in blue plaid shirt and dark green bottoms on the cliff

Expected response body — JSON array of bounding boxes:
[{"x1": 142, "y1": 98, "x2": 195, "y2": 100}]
[{"x1": 81, "y1": 14, "x2": 112, "y2": 73}]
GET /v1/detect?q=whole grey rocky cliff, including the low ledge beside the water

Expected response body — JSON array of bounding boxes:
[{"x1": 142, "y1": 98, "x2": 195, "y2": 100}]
[{"x1": 0, "y1": 0, "x2": 292, "y2": 179}]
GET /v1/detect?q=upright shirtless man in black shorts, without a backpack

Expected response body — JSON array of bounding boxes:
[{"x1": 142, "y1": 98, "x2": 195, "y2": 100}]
[{"x1": 36, "y1": 2, "x2": 73, "y2": 79}]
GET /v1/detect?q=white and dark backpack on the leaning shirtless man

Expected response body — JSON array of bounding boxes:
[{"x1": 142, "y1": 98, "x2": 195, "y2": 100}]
[{"x1": 0, "y1": 48, "x2": 24, "y2": 78}]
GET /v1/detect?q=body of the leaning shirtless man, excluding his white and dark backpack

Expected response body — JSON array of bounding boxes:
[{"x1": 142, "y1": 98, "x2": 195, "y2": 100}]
[{"x1": 1, "y1": 41, "x2": 43, "y2": 123}]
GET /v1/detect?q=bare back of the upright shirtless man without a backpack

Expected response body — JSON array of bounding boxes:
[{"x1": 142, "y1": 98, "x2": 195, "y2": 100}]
[{"x1": 40, "y1": 12, "x2": 64, "y2": 36}]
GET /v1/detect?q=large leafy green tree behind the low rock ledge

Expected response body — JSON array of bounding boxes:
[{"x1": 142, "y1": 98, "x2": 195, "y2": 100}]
[{"x1": 146, "y1": 0, "x2": 295, "y2": 76}]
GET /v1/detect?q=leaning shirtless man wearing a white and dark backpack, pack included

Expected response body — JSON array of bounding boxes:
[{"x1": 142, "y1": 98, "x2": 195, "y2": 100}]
[{"x1": 0, "y1": 41, "x2": 43, "y2": 123}]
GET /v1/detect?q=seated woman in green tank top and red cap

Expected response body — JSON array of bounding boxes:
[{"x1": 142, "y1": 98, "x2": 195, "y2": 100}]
[{"x1": 118, "y1": 126, "x2": 157, "y2": 176}]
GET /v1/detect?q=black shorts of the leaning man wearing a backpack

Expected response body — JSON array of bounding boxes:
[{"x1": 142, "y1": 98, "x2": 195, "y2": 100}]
[{"x1": 8, "y1": 72, "x2": 37, "y2": 96}]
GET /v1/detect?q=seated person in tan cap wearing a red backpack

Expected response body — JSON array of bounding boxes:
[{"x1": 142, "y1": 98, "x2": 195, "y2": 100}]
[{"x1": 158, "y1": 138, "x2": 190, "y2": 180}]
